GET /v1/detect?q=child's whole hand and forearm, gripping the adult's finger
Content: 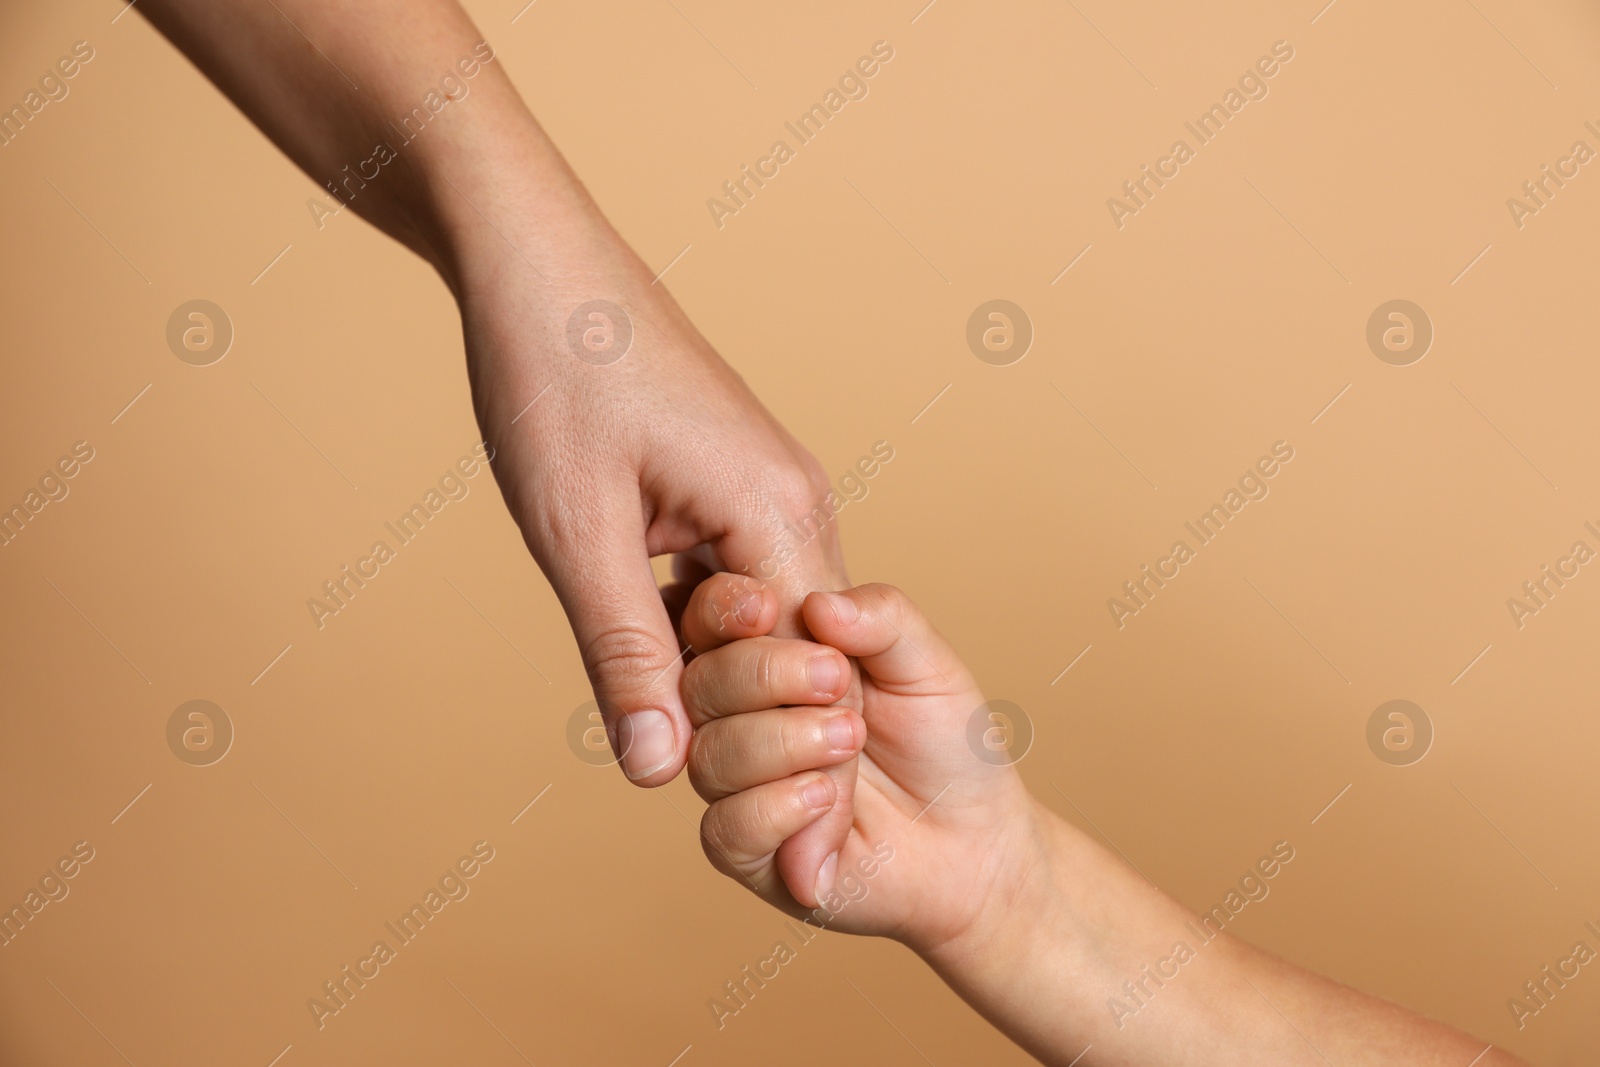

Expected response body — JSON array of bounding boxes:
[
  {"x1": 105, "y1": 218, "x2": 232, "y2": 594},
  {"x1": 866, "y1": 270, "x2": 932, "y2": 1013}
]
[{"x1": 680, "y1": 574, "x2": 1522, "y2": 1067}]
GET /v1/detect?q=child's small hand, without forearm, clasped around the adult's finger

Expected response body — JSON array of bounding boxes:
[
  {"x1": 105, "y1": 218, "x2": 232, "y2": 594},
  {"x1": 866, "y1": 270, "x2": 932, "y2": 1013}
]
[{"x1": 682, "y1": 574, "x2": 1038, "y2": 950}]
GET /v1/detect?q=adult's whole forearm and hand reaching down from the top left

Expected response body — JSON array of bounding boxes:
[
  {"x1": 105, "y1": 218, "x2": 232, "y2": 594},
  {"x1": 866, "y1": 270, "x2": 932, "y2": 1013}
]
[{"x1": 134, "y1": 0, "x2": 854, "y2": 901}]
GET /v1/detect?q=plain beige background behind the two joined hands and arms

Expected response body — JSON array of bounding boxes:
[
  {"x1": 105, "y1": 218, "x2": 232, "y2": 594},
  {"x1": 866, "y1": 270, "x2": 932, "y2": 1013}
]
[{"x1": 0, "y1": 0, "x2": 1600, "y2": 1067}]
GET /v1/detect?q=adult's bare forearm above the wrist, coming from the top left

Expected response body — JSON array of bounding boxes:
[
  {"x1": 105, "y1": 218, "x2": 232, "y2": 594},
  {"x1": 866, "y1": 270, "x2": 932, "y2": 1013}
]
[{"x1": 136, "y1": 0, "x2": 629, "y2": 294}]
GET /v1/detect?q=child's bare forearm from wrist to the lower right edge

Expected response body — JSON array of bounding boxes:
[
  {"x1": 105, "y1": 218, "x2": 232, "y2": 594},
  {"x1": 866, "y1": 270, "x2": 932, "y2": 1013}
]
[{"x1": 923, "y1": 808, "x2": 1518, "y2": 1067}]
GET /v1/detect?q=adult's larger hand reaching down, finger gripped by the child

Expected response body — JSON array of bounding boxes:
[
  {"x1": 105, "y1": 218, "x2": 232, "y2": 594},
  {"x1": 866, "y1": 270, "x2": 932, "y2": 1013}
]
[{"x1": 458, "y1": 219, "x2": 859, "y2": 902}]
